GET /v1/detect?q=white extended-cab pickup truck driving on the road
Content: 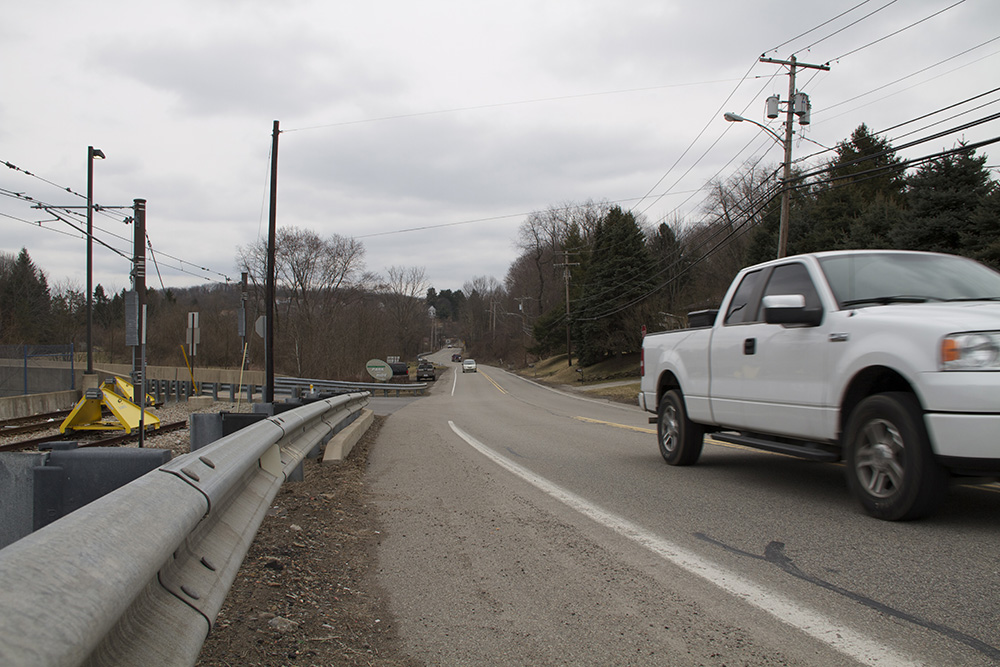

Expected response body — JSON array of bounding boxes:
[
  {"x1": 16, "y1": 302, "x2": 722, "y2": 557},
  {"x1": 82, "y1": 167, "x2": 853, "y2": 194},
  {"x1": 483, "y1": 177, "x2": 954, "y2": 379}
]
[{"x1": 639, "y1": 250, "x2": 1000, "y2": 520}]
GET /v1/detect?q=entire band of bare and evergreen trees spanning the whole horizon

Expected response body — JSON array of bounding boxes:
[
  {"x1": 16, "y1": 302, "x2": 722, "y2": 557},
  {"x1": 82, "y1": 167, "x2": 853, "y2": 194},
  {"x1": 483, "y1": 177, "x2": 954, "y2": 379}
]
[{"x1": 0, "y1": 125, "x2": 1000, "y2": 380}]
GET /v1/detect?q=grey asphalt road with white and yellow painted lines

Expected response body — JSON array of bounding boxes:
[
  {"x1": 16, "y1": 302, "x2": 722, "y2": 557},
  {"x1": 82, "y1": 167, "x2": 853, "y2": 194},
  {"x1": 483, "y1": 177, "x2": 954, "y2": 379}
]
[{"x1": 369, "y1": 350, "x2": 1000, "y2": 665}]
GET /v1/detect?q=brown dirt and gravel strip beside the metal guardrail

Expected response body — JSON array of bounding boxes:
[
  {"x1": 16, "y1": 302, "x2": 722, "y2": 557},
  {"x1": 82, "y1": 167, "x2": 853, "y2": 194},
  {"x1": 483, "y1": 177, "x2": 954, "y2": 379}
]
[{"x1": 197, "y1": 417, "x2": 422, "y2": 667}]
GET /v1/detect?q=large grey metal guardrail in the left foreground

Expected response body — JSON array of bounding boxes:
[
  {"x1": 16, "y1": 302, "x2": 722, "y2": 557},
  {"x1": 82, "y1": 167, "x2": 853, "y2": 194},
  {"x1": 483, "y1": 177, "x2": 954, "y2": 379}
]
[{"x1": 0, "y1": 393, "x2": 368, "y2": 666}]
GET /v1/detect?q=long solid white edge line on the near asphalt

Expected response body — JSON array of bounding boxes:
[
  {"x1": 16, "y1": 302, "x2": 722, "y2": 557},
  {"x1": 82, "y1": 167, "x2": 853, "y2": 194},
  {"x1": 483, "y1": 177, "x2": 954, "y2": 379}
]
[{"x1": 448, "y1": 421, "x2": 922, "y2": 665}]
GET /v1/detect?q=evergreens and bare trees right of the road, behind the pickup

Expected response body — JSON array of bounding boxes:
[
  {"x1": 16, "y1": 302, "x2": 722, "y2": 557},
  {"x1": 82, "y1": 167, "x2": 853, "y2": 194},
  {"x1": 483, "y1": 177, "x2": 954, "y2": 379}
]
[{"x1": 504, "y1": 125, "x2": 1000, "y2": 365}]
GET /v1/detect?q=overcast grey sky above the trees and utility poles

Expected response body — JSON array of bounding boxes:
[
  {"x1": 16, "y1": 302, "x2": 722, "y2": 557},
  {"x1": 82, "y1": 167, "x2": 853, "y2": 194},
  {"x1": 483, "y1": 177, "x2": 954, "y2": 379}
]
[{"x1": 0, "y1": 0, "x2": 1000, "y2": 290}]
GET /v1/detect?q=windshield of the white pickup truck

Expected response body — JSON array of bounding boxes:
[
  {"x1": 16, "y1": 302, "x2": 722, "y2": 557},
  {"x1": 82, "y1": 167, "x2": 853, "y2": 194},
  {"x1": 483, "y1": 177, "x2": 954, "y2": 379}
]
[{"x1": 819, "y1": 252, "x2": 1000, "y2": 308}]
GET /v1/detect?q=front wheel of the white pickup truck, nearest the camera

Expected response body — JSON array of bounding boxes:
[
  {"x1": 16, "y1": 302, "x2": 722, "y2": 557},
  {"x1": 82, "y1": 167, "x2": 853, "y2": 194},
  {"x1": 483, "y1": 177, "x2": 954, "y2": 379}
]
[{"x1": 844, "y1": 392, "x2": 948, "y2": 521}]
